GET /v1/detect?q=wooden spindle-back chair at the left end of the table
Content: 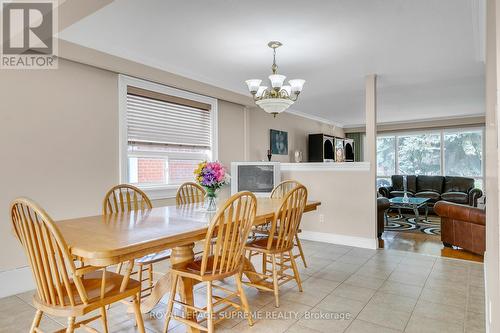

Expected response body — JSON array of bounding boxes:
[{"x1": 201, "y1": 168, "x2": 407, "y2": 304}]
[{"x1": 10, "y1": 198, "x2": 144, "y2": 333}]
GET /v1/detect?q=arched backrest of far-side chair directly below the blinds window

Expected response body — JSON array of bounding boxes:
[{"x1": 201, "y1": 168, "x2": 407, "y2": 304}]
[{"x1": 102, "y1": 184, "x2": 153, "y2": 215}]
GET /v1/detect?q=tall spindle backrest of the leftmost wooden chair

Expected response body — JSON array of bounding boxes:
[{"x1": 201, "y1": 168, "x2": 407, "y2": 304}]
[{"x1": 10, "y1": 198, "x2": 88, "y2": 307}]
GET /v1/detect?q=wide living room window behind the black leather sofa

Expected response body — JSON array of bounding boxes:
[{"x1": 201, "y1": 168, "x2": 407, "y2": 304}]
[{"x1": 377, "y1": 128, "x2": 484, "y2": 189}]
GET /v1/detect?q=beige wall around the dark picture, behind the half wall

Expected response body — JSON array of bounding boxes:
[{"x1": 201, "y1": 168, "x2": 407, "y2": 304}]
[{"x1": 248, "y1": 108, "x2": 344, "y2": 162}]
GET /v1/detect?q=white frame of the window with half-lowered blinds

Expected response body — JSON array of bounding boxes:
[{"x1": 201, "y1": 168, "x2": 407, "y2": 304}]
[{"x1": 118, "y1": 74, "x2": 219, "y2": 200}]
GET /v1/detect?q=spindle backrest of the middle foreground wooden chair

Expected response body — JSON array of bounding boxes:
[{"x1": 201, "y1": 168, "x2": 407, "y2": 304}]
[{"x1": 201, "y1": 191, "x2": 257, "y2": 275}]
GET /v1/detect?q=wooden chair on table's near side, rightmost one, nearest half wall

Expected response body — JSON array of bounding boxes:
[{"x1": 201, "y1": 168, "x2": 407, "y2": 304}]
[{"x1": 245, "y1": 185, "x2": 307, "y2": 307}]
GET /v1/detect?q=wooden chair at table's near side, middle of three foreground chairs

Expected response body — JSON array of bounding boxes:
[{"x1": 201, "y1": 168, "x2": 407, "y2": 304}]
[{"x1": 163, "y1": 192, "x2": 257, "y2": 333}]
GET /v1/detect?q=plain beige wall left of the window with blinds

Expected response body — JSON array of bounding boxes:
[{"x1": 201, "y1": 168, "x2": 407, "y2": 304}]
[{"x1": 0, "y1": 60, "x2": 119, "y2": 271}]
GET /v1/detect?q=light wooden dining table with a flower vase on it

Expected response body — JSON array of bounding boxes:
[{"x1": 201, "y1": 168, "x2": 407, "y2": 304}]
[{"x1": 56, "y1": 198, "x2": 321, "y2": 330}]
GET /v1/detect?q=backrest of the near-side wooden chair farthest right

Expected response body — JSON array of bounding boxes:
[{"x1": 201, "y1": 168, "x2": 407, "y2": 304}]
[{"x1": 267, "y1": 185, "x2": 307, "y2": 250}]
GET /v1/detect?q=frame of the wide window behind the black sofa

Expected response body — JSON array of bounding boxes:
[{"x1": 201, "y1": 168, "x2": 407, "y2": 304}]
[{"x1": 377, "y1": 126, "x2": 485, "y2": 192}]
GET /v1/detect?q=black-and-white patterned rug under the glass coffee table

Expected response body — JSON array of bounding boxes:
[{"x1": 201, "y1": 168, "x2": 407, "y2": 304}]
[{"x1": 384, "y1": 214, "x2": 441, "y2": 235}]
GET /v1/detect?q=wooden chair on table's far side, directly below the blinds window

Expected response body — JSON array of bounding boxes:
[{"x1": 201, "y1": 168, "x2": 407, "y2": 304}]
[{"x1": 103, "y1": 184, "x2": 167, "y2": 302}]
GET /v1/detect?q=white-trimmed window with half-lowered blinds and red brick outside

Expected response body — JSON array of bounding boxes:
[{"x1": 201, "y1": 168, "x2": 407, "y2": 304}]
[{"x1": 120, "y1": 76, "x2": 217, "y2": 198}]
